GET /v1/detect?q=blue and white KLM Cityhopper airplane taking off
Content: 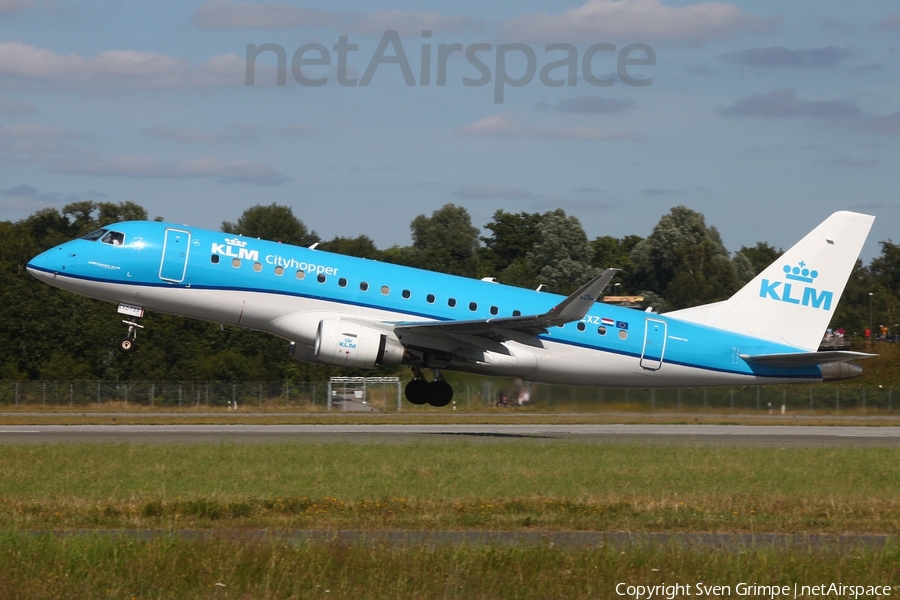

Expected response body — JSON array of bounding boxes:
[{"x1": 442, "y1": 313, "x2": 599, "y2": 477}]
[{"x1": 26, "y1": 211, "x2": 874, "y2": 406}]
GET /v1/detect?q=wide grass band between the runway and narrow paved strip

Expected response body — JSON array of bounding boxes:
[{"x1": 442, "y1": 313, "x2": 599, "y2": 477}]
[{"x1": 0, "y1": 442, "x2": 900, "y2": 534}]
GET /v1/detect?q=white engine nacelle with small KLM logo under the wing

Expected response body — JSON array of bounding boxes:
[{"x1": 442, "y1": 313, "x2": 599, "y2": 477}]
[{"x1": 315, "y1": 319, "x2": 405, "y2": 368}]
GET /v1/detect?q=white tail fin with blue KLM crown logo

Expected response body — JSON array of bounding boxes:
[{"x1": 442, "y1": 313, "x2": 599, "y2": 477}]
[{"x1": 668, "y1": 211, "x2": 875, "y2": 351}]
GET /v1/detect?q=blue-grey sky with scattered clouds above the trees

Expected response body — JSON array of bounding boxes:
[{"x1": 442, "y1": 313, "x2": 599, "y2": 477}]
[{"x1": 0, "y1": 0, "x2": 900, "y2": 260}]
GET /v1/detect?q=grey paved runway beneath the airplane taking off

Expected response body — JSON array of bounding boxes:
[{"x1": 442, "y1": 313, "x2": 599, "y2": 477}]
[{"x1": 0, "y1": 424, "x2": 900, "y2": 447}]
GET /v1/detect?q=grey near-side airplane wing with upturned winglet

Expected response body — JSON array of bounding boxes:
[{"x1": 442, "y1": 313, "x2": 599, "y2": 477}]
[{"x1": 394, "y1": 269, "x2": 619, "y2": 346}]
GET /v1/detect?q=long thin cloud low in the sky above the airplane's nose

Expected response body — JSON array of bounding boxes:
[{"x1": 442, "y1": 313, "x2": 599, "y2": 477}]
[{"x1": 50, "y1": 156, "x2": 288, "y2": 185}]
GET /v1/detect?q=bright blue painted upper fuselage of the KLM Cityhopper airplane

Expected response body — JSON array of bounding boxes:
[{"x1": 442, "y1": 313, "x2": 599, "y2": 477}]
[{"x1": 29, "y1": 222, "x2": 819, "y2": 378}]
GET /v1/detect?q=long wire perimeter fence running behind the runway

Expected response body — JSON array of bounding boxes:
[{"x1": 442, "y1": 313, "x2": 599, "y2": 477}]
[{"x1": 0, "y1": 379, "x2": 900, "y2": 414}]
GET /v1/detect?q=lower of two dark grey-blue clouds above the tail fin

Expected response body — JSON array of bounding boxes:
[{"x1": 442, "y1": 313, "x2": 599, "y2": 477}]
[{"x1": 717, "y1": 89, "x2": 862, "y2": 119}]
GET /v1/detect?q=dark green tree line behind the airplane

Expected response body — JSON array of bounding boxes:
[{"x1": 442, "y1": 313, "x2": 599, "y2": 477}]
[{"x1": 0, "y1": 201, "x2": 900, "y2": 381}]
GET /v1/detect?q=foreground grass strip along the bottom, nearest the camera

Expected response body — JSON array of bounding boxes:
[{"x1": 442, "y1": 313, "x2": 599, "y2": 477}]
[{"x1": 0, "y1": 533, "x2": 900, "y2": 600}]
